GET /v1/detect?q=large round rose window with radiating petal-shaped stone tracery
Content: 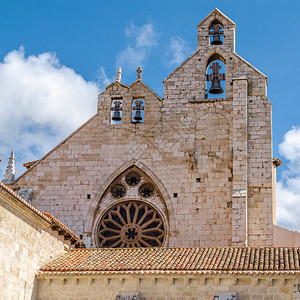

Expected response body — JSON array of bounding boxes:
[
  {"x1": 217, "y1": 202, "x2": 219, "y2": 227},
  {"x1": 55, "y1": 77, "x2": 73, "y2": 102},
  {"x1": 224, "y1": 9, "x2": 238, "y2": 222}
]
[{"x1": 98, "y1": 201, "x2": 165, "y2": 248}]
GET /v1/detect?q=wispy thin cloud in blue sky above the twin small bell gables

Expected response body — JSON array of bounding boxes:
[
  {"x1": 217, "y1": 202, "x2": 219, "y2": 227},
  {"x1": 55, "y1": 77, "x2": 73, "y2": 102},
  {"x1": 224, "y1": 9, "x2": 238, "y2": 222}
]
[{"x1": 117, "y1": 23, "x2": 157, "y2": 70}]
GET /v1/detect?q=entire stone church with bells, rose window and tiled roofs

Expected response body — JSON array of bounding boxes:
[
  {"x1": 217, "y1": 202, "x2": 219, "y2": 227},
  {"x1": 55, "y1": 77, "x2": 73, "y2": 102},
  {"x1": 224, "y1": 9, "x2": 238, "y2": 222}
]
[{"x1": 0, "y1": 9, "x2": 300, "y2": 300}]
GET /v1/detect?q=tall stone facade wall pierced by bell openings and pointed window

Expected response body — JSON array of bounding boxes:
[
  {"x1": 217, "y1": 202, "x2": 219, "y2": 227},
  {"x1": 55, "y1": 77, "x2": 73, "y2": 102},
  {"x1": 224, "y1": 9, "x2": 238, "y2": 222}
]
[{"x1": 14, "y1": 11, "x2": 273, "y2": 247}]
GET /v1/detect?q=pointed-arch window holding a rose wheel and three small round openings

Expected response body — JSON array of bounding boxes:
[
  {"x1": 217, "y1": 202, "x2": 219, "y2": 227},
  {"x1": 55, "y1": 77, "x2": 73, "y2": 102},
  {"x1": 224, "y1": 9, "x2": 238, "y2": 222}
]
[{"x1": 93, "y1": 166, "x2": 169, "y2": 248}]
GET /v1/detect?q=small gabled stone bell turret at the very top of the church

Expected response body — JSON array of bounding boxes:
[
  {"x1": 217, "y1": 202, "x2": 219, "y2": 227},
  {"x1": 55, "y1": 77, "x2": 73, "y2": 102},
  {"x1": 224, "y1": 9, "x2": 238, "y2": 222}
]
[{"x1": 197, "y1": 8, "x2": 235, "y2": 52}]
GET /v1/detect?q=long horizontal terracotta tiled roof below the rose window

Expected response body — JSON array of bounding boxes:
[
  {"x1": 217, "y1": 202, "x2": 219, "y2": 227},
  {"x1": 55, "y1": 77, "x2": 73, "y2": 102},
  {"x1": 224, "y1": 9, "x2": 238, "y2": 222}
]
[{"x1": 39, "y1": 247, "x2": 300, "y2": 276}]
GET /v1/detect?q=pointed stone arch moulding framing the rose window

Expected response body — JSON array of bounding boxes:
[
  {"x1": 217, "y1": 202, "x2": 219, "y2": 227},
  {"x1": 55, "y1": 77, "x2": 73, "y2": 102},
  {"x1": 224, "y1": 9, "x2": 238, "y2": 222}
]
[{"x1": 85, "y1": 159, "x2": 176, "y2": 245}]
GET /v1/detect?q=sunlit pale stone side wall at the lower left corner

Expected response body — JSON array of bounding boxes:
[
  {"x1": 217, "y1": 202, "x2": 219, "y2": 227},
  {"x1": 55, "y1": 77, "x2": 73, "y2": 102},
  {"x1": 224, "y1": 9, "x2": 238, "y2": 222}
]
[{"x1": 0, "y1": 188, "x2": 65, "y2": 300}]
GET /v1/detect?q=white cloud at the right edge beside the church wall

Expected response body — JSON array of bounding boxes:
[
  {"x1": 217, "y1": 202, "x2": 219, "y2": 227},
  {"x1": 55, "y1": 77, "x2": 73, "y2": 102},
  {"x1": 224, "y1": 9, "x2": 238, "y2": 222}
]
[{"x1": 277, "y1": 127, "x2": 300, "y2": 231}]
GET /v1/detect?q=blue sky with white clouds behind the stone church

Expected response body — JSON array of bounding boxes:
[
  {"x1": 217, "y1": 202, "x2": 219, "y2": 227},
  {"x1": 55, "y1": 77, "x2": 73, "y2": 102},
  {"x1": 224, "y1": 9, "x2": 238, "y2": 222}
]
[{"x1": 0, "y1": 0, "x2": 300, "y2": 229}]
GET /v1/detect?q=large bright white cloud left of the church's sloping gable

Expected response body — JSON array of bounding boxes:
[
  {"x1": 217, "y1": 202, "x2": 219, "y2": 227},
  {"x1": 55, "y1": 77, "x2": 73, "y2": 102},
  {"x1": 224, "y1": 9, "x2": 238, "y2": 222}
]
[{"x1": 0, "y1": 47, "x2": 98, "y2": 180}]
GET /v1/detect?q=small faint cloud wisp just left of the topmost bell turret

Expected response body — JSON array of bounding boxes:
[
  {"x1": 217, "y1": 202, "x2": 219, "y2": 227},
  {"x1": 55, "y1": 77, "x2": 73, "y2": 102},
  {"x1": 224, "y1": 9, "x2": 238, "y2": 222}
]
[{"x1": 169, "y1": 36, "x2": 192, "y2": 66}]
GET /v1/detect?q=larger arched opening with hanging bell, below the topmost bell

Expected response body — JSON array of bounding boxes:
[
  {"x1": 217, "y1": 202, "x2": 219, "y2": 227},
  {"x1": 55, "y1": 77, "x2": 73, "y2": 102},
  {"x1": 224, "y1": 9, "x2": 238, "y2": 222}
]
[{"x1": 205, "y1": 53, "x2": 226, "y2": 99}]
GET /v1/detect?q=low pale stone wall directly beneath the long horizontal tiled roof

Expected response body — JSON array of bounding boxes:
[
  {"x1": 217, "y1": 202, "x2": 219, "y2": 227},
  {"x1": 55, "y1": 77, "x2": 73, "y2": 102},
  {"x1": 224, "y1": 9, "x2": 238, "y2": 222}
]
[{"x1": 37, "y1": 275, "x2": 300, "y2": 300}]
